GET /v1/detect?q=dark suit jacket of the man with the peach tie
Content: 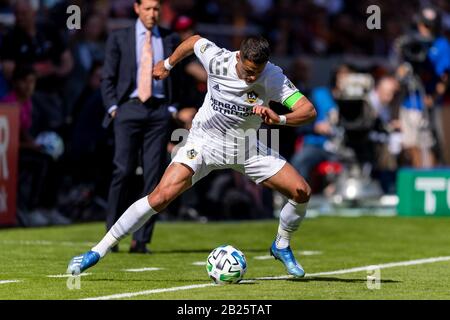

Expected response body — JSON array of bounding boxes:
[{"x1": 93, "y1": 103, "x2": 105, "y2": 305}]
[{"x1": 101, "y1": 24, "x2": 180, "y2": 127}]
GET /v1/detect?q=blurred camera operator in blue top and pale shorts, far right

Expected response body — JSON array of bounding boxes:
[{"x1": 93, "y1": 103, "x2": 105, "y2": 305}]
[{"x1": 395, "y1": 7, "x2": 450, "y2": 167}]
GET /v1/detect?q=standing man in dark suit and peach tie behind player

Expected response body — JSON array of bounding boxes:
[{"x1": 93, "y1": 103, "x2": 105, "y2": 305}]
[{"x1": 102, "y1": 0, "x2": 179, "y2": 253}]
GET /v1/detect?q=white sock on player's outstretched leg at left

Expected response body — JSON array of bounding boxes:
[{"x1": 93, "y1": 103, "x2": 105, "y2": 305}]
[{"x1": 92, "y1": 196, "x2": 157, "y2": 258}]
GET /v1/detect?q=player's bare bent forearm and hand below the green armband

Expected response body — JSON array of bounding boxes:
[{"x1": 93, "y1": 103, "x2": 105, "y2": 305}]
[{"x1": 253, "y1": 96, "x2": 317, "y2": 127}]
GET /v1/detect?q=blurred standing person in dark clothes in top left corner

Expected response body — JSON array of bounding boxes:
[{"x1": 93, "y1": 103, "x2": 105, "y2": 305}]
[{"x1": 1, "y1": 0, "x2": 73, "y2": 133}]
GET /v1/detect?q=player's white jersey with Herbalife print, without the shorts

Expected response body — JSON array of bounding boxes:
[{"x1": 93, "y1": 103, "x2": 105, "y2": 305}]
[{"x1": 192, "y1": 38, "x2": 298, "y2": 146}]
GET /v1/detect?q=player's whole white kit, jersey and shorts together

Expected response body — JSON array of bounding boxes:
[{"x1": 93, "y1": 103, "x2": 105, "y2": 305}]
[{"x1": 172, "y1": 39, "x2": 298, "y2": 184}]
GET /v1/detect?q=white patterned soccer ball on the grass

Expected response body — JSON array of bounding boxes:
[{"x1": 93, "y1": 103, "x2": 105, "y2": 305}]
[{"x1": 206, "y1": 245, "x2": 247, "y2": 284}]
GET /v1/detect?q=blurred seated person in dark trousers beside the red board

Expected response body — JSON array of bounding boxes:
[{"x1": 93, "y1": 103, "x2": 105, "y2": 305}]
[{"x1": 2, "y1": 66, "x2": 70, "y2": 226}]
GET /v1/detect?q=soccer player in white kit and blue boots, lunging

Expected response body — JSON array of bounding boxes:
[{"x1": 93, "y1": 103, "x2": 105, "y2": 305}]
[{"x1": 67, "y1": 35, "x2": 316, "y2": 277}]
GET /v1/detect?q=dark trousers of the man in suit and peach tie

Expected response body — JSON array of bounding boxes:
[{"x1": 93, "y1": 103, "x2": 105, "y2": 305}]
[{"x1": 106, "y1": 99, "x2": 171, "y2": 243}]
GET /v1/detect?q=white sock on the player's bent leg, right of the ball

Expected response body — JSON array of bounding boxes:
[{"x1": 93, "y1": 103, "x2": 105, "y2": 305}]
[{"x1": 275, "y1": 200, "x2": 308, "y2": 249}]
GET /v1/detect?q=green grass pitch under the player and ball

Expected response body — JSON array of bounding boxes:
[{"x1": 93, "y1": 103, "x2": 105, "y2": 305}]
[{"x1": 0, "y1": 217, "x2": 450, "y2": 300}]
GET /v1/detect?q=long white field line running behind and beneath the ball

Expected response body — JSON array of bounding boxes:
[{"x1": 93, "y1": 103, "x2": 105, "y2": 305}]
[{"x1": 82, "y1": 256, "x2": 450, "y2": 300}]
